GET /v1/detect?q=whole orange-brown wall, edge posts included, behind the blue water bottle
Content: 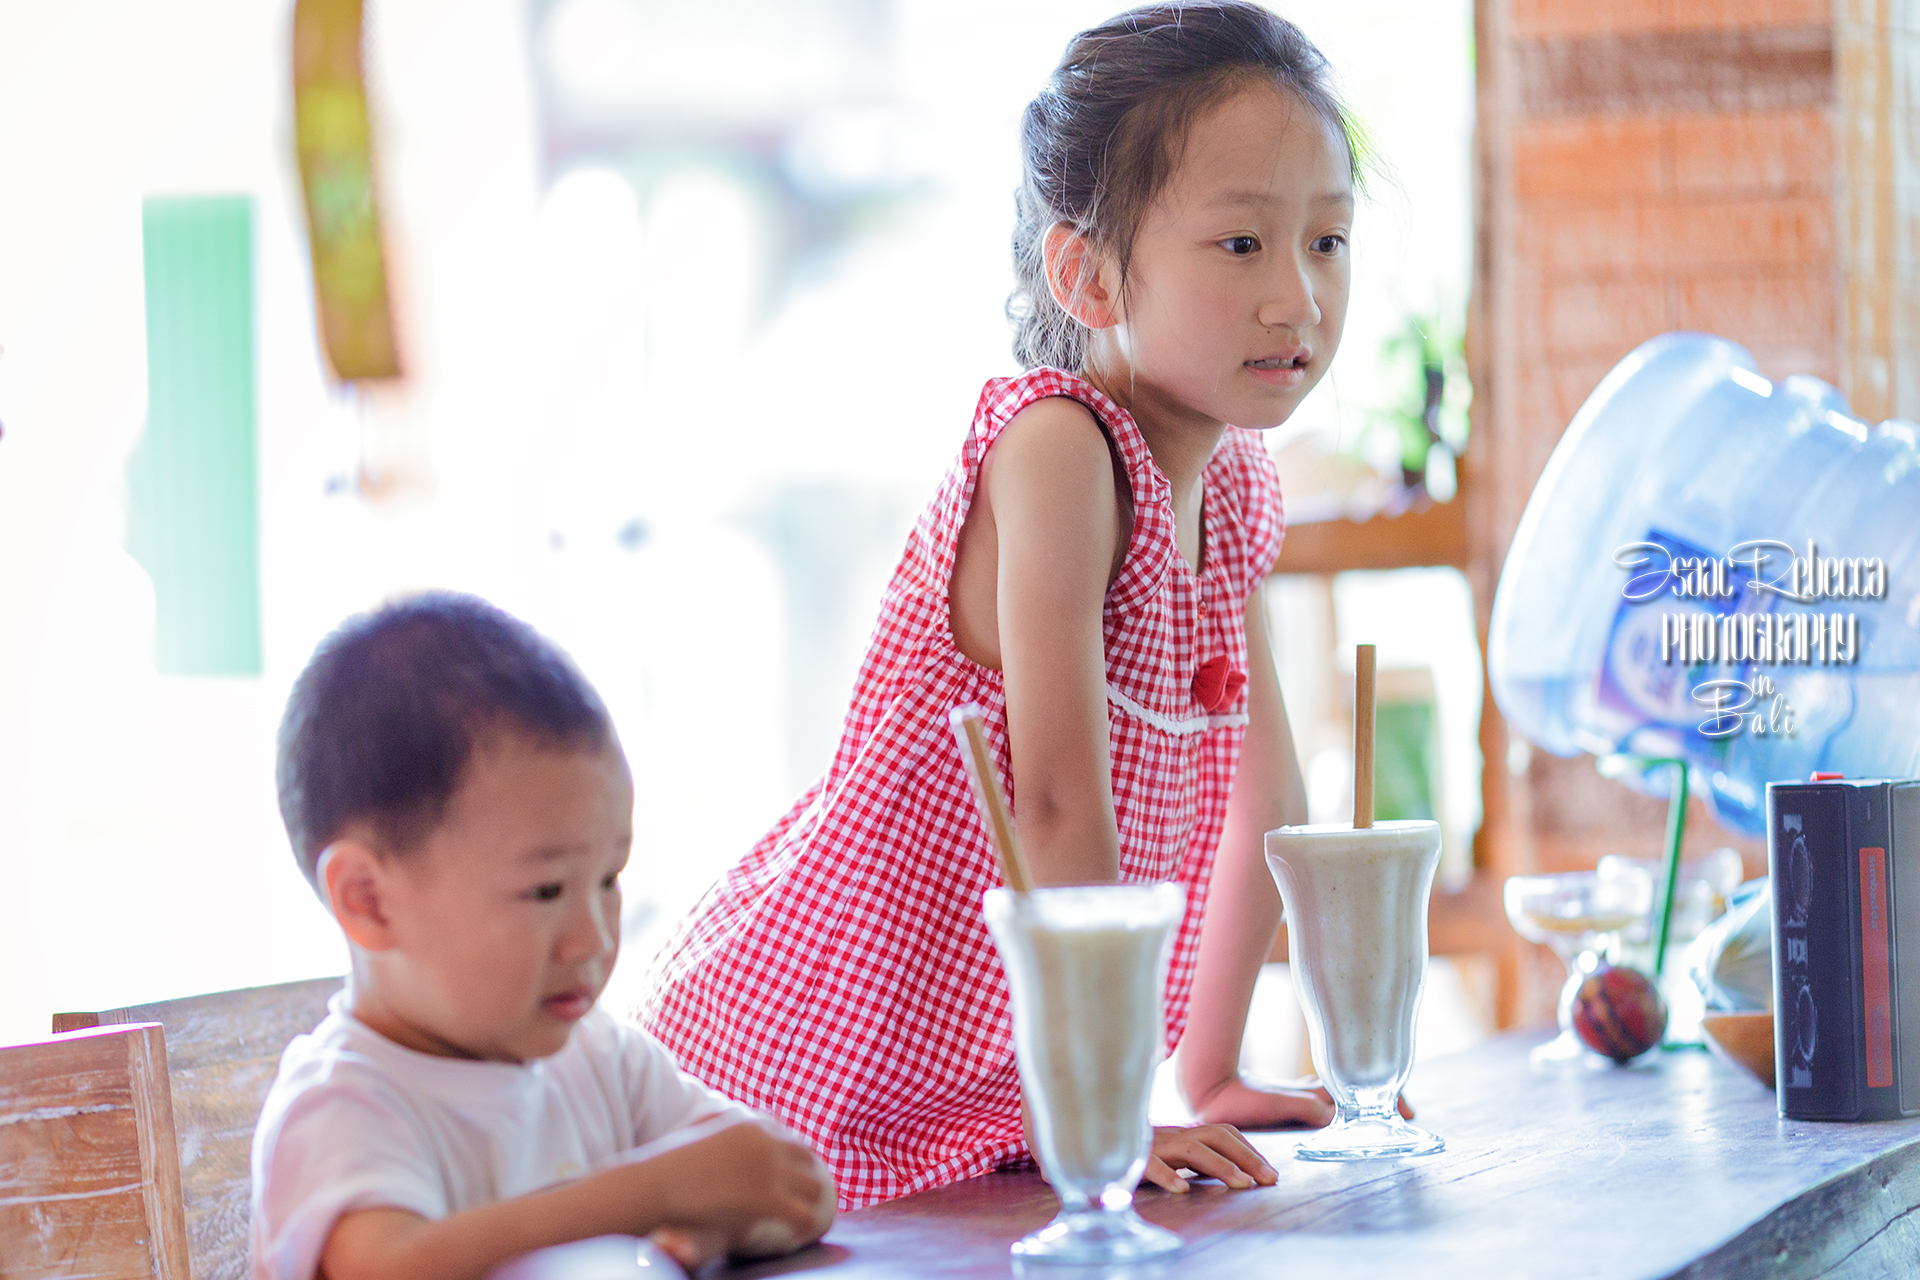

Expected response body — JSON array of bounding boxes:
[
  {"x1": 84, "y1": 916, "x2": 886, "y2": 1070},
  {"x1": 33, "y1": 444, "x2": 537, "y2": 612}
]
[{"x1": 1469, "y1": 0, "x2": 1920, "y2": 1021}]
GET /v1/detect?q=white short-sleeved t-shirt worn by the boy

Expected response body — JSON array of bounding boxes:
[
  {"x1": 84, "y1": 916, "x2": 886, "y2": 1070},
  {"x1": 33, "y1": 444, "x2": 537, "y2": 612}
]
[{"x1": 250, "y1": 992, "x2": 749, "y2": 1280}]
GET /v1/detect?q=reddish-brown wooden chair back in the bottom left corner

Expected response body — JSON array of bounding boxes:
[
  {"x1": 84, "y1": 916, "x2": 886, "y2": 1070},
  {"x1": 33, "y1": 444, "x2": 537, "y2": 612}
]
[{"x1": 0, "y1": 1023, "x2": 188, "y2": 1280}]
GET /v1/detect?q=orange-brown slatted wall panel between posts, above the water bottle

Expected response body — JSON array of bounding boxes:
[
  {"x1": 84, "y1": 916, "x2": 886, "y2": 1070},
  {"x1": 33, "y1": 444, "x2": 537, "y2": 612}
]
[{"x1": 1488, "y1": 0, "x2": 1839, "y2": 506}]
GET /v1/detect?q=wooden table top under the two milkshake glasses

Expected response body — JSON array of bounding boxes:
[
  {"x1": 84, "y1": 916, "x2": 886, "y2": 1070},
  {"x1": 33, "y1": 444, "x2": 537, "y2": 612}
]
[{"x1": 724, "y1": 1034, "x2": 1920, "y2": 1280}]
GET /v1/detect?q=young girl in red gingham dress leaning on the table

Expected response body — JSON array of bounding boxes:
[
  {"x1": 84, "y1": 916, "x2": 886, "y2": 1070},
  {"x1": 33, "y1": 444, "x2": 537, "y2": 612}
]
[{"x1": 641, "y1": 4, "x2": 1356, "y2": 1207}]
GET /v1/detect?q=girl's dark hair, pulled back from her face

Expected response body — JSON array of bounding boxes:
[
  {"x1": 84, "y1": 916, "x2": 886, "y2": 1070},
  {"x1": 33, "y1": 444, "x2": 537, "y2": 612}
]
[{"x1": 1006, "y1": 0, "x2": 1365, "y2": 370}]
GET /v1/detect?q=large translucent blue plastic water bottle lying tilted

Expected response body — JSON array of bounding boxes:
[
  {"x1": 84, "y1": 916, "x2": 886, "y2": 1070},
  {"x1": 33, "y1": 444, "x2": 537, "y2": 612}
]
[{"x1": 1488, "y1": 334, "x2": 1920, "y2": 835}]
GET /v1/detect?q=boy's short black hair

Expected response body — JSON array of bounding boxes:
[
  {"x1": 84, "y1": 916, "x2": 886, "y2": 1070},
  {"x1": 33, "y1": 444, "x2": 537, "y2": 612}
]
[{"x1": 276, "y1": 591, "x2": 612, "y2": 883}]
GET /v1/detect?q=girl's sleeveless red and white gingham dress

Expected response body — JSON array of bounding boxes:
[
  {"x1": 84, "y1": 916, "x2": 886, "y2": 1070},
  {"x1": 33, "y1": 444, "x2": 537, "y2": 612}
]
[{"x1": 639, "y1": 368, "x2": 1283, "y2": 1209}]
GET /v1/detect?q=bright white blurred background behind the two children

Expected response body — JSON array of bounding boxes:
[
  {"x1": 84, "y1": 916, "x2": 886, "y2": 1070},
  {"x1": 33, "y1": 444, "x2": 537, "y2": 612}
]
[{"x1": 0, "y1": 0, "x2": 1478, "y2": 1057}]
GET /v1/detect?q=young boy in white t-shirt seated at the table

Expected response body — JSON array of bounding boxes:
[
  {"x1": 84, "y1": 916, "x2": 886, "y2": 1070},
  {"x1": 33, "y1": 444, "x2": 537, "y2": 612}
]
[{"x1": 252, "y1": 595, "x2": 833, "y2": 1280}]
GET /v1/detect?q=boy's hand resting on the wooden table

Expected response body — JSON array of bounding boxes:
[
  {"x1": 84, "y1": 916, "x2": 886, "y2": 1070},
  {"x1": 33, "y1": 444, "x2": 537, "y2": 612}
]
[{"x1": 647, "y1": 1121, "x2": 835, "y2": 1253}]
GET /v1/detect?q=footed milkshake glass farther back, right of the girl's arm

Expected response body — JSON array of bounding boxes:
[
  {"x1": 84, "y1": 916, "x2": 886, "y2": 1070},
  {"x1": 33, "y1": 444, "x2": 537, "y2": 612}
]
[{"x1": 1267, "y1": 821, "x2": 1444, "y2": 1159}]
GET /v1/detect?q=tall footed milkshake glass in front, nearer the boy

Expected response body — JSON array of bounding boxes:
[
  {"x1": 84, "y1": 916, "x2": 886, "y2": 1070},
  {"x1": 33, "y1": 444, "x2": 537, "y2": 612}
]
[{"x1": 985, "y1": 885, "x2": 1187, "y2": 1263}]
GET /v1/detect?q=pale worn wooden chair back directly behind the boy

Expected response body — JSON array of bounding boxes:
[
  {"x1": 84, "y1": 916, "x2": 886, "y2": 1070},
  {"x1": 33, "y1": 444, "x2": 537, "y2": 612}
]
[{"x1": 51, "y1": 979, "x2": 342, "y2": 1280}]
